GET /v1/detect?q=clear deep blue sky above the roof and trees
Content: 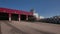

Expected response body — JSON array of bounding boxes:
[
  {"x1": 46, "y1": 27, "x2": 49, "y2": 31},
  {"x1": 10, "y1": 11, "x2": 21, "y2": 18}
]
[{"x1": 0, "y1": 0, "x2": 60, "y2": 17}]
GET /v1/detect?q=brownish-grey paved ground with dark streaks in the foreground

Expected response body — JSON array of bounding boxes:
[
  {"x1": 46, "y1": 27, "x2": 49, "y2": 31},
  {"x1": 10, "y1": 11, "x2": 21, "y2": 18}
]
[{"x1": 1, "y1": 21, "x2": 60, "y2": 34}]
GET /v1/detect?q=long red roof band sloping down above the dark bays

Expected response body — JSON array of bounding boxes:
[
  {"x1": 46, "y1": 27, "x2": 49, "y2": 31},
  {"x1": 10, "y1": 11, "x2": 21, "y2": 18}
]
[{"x1": 0, "y1": 8, "x2": 32, "y2": 15}]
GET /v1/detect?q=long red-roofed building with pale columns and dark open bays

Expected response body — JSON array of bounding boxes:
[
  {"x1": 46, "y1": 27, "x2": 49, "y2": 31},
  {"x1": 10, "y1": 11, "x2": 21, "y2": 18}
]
[{"x1": 0, "y1": 8, "x2": 33, "y2": 21}]
